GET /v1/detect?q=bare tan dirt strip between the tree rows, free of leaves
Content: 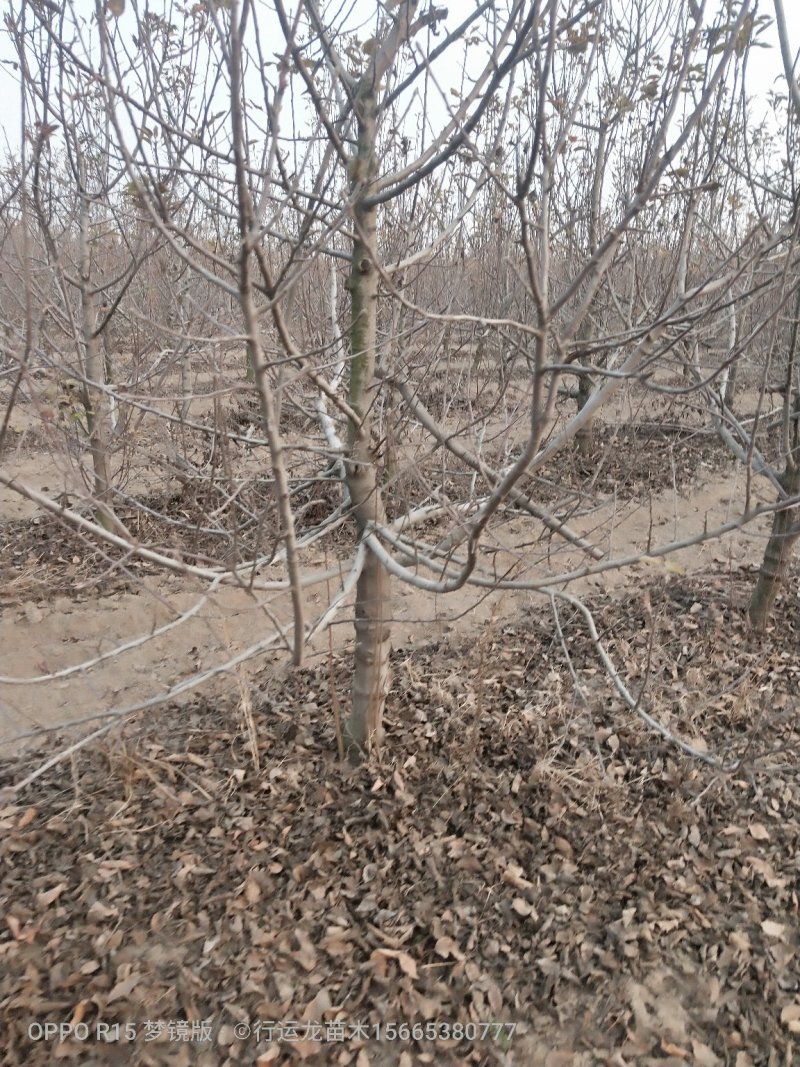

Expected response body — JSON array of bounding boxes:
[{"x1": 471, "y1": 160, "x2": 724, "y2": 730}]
[{"x1": 0, "y1": 379, "x2": 770, "y2": 747}]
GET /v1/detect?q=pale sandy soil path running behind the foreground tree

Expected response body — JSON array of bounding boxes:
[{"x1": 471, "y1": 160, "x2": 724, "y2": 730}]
[{"x1": 0, "y1": 375, "x2": 785, "y2": 751}]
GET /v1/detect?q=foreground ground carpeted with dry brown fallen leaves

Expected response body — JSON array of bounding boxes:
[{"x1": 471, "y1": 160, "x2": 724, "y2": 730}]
[{"x1": 0, "y1": 574, "x2": 800, "y2": 1067}]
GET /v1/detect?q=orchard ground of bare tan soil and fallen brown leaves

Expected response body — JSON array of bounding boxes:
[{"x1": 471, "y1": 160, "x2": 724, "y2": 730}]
[{"x1": 0, "y1": 371, "x2": 800, "y2": 1067}]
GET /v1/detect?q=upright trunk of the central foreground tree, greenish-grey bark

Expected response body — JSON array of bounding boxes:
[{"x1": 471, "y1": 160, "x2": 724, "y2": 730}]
[{"x1": 345, "y1": 87, "x2": 391, "y2": 759}]
